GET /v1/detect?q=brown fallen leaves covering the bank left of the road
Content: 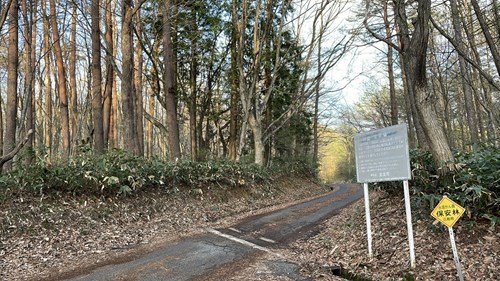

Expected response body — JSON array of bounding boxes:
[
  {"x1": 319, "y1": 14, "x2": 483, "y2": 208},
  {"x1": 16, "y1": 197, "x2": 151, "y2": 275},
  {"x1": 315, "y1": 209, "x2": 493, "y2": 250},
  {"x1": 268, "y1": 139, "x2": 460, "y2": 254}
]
[{"x1": 0, "y1": 178, "x2": 326, "y2": 281}]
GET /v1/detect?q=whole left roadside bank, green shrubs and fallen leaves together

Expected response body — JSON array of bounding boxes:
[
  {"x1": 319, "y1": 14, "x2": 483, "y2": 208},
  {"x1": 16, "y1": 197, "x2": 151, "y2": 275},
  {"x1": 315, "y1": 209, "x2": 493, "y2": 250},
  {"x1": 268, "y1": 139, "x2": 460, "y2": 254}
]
[{"x1": 0, "y1": 150, "x2": 329, "y2": 280}]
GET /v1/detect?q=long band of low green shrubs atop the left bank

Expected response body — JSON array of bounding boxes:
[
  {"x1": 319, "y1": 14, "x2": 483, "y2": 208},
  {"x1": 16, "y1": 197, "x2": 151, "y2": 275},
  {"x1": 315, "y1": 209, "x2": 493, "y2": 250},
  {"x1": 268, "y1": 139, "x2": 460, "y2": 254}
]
[{"x1": 0, "y1": 149, "x2": 310, "y2": 196}]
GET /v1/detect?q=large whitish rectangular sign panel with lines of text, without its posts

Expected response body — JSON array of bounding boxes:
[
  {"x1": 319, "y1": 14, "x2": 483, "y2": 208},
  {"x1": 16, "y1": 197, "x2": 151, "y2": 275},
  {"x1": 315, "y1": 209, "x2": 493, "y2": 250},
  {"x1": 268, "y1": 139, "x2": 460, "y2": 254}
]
[{"x1": 354, "y1": 124, "x2": 411, "y2": 183}]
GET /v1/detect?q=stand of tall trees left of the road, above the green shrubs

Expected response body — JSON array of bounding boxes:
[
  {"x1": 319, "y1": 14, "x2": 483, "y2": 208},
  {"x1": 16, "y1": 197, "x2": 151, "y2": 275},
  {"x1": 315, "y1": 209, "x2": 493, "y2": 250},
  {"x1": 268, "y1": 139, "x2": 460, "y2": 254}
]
[{"x1": 1, "y1": 0, "x2": 352, "y2": 166}]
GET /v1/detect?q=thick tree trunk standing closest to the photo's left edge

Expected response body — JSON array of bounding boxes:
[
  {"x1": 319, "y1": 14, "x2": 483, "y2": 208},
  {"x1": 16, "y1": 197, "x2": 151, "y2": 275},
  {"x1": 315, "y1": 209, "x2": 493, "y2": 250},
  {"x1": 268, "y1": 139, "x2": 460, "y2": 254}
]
[{"x1": 2, "y1": 0, "x2": 19, "y2": 171}]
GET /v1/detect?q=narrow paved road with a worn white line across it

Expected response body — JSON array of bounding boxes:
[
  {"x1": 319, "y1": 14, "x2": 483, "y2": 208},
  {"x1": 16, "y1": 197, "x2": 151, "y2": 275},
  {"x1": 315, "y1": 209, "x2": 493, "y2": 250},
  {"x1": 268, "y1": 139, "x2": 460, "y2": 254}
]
[{"x1": 67, "y1": 184, "x2": 363, "y2": 281}]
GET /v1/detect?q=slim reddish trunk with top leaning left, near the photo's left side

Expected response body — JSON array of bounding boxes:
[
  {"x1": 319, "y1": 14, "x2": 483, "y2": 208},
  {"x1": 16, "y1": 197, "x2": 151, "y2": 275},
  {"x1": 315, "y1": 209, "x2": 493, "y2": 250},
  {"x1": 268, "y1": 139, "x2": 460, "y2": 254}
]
[{"x1": 49, "y1": 0, "x2": 71, "y2": 157}]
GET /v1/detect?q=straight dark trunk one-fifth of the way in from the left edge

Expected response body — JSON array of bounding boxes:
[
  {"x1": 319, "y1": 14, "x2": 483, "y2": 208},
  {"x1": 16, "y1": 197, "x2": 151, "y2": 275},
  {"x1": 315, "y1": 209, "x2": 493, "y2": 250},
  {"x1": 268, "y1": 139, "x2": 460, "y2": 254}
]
[{"x1": 91, "y1": 0, "x2": 104, "y2": 153}]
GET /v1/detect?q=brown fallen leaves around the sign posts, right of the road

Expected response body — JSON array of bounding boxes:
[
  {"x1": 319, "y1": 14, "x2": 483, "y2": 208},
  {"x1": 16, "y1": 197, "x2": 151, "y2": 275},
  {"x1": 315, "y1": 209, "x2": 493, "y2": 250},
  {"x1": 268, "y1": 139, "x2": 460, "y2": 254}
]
[{"x1": 288, "y1": 191, "x2": 500, "y2": 281}]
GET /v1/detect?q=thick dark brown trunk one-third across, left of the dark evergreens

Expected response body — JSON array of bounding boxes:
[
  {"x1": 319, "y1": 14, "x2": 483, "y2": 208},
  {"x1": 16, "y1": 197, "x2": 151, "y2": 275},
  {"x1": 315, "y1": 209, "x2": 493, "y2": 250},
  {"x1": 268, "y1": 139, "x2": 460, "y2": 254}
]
[{"x1": 163, "y1": 0, "x2": 181, "y2": 161}]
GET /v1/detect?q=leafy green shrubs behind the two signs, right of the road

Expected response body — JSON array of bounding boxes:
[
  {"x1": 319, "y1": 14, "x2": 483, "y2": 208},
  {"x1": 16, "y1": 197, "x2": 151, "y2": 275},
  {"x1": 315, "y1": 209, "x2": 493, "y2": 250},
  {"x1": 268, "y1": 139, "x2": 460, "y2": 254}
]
[{"x1": 377, "y1": 147, "x2": 500, "y2": 225}]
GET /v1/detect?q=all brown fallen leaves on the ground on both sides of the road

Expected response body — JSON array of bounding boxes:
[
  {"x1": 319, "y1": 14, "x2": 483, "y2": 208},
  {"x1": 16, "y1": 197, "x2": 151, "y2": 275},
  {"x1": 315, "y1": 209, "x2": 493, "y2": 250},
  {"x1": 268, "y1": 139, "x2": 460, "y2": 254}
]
[{"x1": 0, "y1": 178, "x2": 500, "y2": 281}]
